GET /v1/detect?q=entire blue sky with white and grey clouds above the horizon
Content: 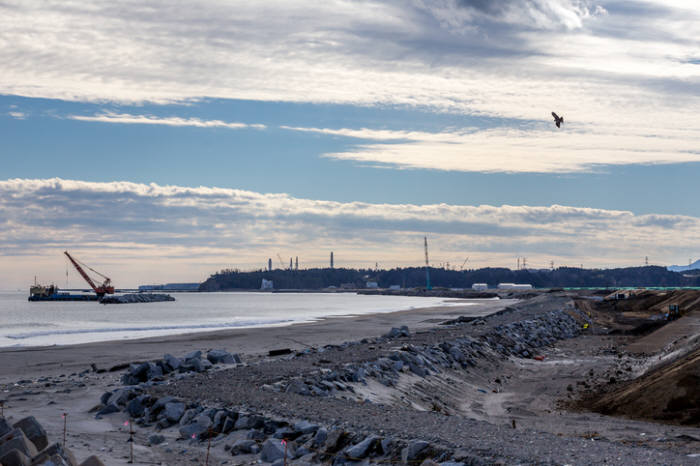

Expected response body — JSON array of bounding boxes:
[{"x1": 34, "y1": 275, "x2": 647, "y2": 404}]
[{"x1": 0, "y1": 0, "x2": 700, "y2": 289}]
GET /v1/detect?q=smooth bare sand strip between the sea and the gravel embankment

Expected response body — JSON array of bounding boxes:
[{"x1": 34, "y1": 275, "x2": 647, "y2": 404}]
[{"x1": 0, "y1": 300, "x2": 508, "y2": 383}]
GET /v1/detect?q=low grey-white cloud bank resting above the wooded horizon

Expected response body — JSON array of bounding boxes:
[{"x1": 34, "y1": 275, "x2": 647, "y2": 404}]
[{"x1": 0, "y1": 178, "x2": 700, "y2": 286}]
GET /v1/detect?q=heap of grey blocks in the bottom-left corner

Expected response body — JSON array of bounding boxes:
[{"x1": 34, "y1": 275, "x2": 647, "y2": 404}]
[{"x1": 0, "y1": 416, "x2": 104, "y2": 466}]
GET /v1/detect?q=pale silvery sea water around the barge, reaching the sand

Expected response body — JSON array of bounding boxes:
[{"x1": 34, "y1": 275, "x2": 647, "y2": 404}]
[{"x1": 0, "y1": 292, "x2": 476, "y2": 347}]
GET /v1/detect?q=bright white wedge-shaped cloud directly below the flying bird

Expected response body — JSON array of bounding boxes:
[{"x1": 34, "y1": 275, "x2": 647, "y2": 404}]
[{"x1": 286, "y1": 123, "x2": 700, "y2": 173}]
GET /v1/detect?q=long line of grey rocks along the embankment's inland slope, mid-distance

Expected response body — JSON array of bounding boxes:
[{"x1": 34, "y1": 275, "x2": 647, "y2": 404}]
[{"x1": 262, "y1": 310, "x2": 584, "y2": 396}]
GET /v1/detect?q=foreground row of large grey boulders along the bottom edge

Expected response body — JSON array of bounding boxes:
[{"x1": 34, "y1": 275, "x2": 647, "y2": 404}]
[{"x1": 95, "y1": 388, "x2": 474, "y2": 465}]
